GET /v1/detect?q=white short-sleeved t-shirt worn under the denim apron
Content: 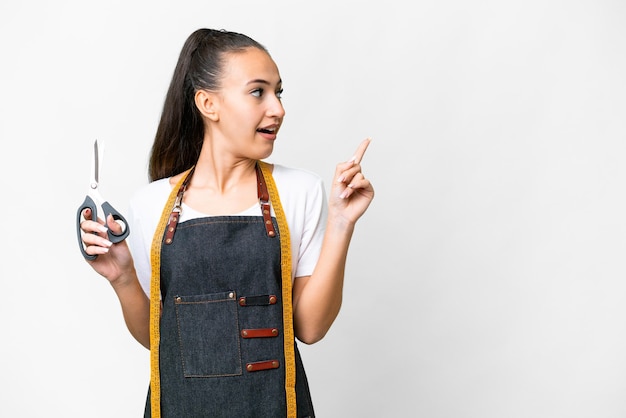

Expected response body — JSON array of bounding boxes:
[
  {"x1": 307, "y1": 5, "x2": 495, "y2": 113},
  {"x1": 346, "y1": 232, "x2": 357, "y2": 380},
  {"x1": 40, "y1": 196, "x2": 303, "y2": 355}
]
[{"x1": 127, "y1": 164, "x2": 328, "y2": 297}]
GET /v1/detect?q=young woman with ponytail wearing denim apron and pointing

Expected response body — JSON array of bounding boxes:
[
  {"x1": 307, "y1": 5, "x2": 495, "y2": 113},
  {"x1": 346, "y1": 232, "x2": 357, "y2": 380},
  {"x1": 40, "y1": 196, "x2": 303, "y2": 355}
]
[{"x1": 81, "y1": 29, "x2": 374, "y2": 418}]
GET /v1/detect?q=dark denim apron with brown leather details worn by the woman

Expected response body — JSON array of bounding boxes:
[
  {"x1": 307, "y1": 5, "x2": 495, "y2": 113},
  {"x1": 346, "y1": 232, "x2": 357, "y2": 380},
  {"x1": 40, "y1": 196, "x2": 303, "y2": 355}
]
[{"x1": 144, "y1": 164, "x2": 314, "y2": 418}]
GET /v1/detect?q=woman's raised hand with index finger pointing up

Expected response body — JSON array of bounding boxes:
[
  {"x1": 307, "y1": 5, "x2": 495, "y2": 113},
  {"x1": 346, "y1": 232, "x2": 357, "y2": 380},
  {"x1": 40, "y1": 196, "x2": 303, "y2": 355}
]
[{"x1": 328, "y1": 138, "x2": 374, "y2": 225}]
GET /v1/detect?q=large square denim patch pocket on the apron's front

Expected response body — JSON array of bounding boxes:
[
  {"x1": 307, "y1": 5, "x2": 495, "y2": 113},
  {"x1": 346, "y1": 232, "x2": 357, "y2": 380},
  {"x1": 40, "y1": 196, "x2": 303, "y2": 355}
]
[{"x1": 174, "y1": 291, "x2": 242, "y2": 377}]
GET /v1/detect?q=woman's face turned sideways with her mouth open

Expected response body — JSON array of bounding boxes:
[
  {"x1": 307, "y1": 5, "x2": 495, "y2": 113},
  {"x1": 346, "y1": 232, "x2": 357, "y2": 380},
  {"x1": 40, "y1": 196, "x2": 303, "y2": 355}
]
[{"x1": 213, "y1": 48, "x2": 285, "y2": 159}]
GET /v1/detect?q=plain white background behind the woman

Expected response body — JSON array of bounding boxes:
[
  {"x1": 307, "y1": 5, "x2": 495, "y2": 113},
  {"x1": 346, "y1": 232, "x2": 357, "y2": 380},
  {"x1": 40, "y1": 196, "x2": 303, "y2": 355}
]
[{"x1": 0, "y1": 0, "x2": 626, "y2": 418}]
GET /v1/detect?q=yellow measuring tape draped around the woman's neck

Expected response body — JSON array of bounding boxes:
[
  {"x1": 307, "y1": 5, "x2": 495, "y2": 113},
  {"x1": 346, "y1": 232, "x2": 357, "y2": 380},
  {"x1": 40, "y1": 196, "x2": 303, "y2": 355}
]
[{"x1": 150, "y1": 161, "x2": 296, "y2": 418}]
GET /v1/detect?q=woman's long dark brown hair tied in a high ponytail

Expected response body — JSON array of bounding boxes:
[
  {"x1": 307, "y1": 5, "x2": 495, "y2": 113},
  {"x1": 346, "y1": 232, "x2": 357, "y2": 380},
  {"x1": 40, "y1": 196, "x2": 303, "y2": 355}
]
[{"x1": 148, "y1": 29, "x2": 267, "y2": 181}]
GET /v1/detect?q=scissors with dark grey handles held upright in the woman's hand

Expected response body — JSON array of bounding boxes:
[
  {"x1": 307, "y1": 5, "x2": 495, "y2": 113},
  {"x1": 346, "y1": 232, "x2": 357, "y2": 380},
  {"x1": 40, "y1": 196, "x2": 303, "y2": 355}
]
[{"x1": 76, "y1": 139, "x2": 130, "y2": 260}]
